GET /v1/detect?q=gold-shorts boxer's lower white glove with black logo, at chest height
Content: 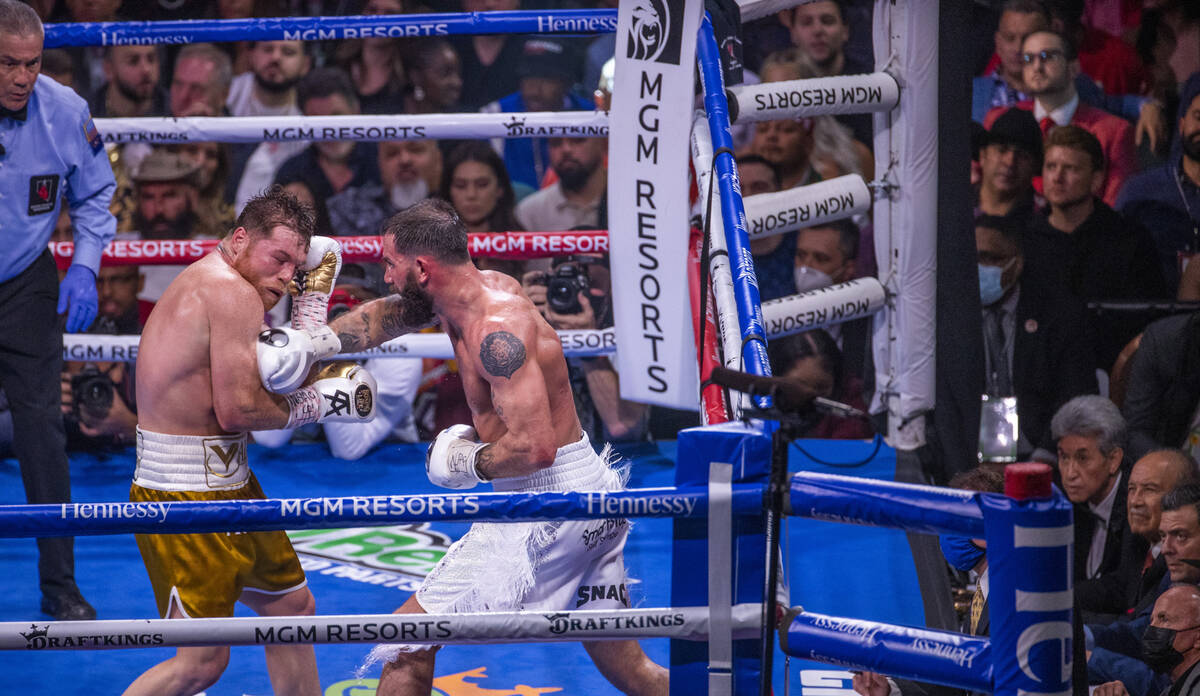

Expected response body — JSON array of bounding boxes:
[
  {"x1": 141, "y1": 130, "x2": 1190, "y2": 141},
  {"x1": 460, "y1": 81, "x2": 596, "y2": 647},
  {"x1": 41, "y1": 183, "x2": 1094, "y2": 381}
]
[{"x1": 283, "y1": 361, "x2": 378, "y2": 428}]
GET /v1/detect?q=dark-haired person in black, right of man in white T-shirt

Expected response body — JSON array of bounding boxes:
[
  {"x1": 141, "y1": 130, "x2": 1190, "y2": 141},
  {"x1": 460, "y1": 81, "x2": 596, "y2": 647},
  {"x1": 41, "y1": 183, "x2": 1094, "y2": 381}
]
[{"x1": 275, "y1": 67, "x2": 379, "y2": 224}]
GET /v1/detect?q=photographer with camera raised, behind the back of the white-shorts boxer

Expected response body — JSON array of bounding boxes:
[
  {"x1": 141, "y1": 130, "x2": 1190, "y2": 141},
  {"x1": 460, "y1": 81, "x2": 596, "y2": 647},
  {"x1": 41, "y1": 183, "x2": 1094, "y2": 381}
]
[{"x1": 522, "y1": 254, "x2": 649, "y2": 442}]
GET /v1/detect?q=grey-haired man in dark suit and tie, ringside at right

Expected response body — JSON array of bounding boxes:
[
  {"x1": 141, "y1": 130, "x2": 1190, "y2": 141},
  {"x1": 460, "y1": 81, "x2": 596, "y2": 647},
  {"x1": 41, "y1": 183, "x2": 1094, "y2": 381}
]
[{"x1": 1050, "y1": 396, "x2": 1130, "y2": 582}]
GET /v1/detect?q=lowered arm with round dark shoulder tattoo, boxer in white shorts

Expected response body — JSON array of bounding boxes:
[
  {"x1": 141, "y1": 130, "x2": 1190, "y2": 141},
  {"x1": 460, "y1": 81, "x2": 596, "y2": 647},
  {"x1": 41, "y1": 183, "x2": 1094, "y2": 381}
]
[{"x1": 475, "y1": 319, "x2": 558, "y2": 479}]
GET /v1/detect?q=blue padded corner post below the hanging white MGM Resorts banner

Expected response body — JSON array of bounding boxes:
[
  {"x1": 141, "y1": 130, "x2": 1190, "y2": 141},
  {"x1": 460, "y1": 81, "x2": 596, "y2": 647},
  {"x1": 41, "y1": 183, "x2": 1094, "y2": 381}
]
[{"x1": 671, "y1": 422, "x2": 770, "y2": 696}]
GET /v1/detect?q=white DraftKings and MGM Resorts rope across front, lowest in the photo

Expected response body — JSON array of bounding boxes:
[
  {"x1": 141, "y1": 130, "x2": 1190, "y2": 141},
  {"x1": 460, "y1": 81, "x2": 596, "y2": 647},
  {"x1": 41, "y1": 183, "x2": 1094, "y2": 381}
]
[{"x1": 0, "y1": 604, "x2": 762, "y2": 650}]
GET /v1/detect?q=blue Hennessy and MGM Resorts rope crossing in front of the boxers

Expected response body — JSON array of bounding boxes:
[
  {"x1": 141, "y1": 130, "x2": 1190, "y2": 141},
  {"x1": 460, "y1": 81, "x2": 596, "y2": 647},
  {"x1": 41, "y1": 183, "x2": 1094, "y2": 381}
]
[{"x1": 0, "y1": 484, "x2": 763, "y2": 538}]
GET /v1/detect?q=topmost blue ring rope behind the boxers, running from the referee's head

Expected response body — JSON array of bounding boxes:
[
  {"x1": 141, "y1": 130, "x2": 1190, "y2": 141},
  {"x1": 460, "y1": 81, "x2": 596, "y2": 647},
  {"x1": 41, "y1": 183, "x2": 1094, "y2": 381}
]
[{"x1": 44, "y1": 10, "x2": 617, "y2": 48}]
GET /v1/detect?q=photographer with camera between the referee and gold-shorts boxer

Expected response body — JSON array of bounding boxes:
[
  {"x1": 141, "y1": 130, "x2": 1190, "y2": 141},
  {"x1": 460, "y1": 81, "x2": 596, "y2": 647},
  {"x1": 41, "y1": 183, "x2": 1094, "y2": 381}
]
[{"x1": 61, "y1": 265, "x2": 154, "y2": 449}]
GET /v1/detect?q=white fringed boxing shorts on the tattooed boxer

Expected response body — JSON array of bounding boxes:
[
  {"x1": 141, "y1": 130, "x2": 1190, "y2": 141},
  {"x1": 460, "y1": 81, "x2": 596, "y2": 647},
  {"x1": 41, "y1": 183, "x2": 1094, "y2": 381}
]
[{"x1": 364, "y1": 434, "x2": 629, "y2": 668}]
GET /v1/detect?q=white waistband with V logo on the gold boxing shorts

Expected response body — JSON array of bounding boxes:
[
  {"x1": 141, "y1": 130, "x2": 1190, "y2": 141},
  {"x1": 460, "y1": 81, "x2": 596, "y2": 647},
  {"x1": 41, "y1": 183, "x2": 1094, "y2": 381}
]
[{"x1": 133, "y1": 428, "x2": 250, "y2": 491}]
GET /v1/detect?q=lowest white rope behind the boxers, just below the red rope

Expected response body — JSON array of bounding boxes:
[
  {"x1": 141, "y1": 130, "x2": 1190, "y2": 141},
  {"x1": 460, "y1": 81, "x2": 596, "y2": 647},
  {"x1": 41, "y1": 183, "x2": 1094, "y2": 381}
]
[{"x1": 62, "y1": 329, "x2": 617, "y2": 362}]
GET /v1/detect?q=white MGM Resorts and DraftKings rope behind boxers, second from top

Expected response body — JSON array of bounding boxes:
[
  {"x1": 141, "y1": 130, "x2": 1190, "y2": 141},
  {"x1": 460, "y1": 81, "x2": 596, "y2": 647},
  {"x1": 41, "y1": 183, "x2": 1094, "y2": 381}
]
[{"x1": 96, "y1": 112, "x2": 608, "y2": 145}]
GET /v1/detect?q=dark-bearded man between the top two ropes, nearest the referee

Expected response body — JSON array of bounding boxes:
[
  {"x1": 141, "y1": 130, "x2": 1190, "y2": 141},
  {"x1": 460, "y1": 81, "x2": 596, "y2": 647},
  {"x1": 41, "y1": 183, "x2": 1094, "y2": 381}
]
[{"x1": 89, "y1": 46, "x2": 168, "y2": 119}]
